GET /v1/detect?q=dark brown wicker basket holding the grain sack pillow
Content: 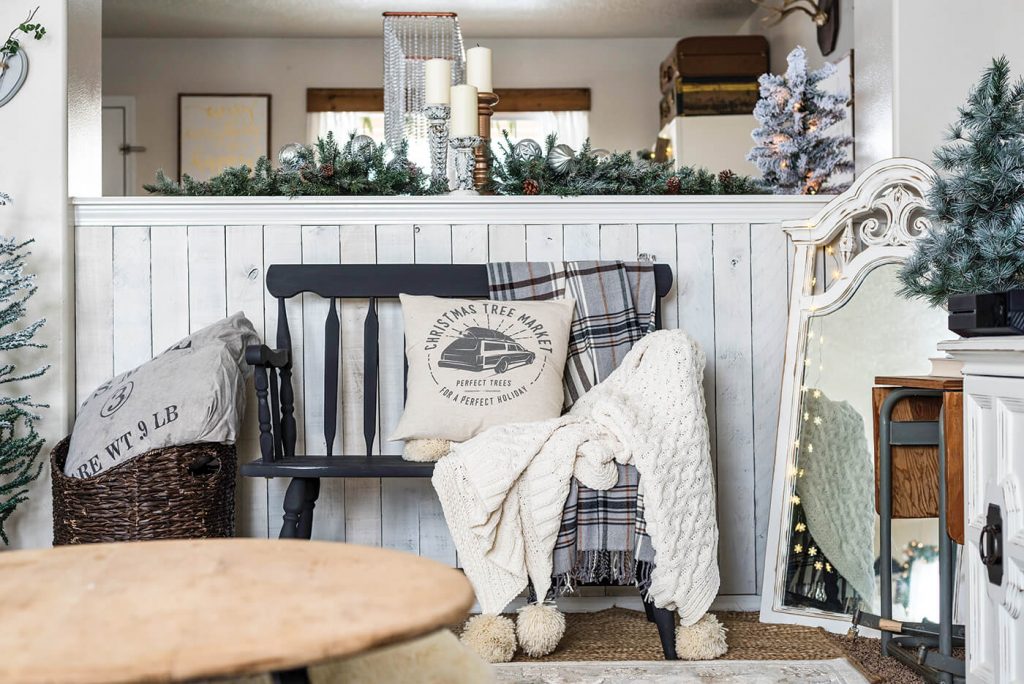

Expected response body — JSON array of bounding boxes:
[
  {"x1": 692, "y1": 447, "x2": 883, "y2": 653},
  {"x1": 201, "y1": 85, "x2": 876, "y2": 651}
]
[{"x1": 50, "y1": 437, "x2": 237, "y2": 545}]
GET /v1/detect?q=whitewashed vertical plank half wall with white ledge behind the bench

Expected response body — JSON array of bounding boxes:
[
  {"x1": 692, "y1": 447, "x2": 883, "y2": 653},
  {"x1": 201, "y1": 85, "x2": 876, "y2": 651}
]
[{"x1": 74, "y1": 198, "x2": 825, "y2": 603}]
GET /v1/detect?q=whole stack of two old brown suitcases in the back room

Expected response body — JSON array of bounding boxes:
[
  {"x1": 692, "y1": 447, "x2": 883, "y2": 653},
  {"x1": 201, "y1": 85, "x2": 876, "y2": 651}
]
[{"x1": 658, "y1": 36, "x2": 768, "y2": 128}]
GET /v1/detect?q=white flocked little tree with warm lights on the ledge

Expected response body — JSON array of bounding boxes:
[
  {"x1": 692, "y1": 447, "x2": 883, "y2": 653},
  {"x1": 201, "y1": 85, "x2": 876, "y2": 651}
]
[{"x1": 746, "y1": 47, "x2": 853, "y2": 195}]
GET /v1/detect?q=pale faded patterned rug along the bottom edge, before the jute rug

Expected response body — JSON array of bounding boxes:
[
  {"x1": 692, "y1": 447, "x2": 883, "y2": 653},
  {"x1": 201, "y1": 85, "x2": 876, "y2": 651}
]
[{"x1": 494, "y1": 658, "x2": 867, "y2": 684}]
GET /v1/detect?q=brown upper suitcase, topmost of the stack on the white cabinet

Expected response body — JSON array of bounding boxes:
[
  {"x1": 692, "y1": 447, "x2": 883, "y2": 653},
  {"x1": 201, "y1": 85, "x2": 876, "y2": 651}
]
[{"x1": 659, "y1": 36, "x2": 768, "y2": 92}]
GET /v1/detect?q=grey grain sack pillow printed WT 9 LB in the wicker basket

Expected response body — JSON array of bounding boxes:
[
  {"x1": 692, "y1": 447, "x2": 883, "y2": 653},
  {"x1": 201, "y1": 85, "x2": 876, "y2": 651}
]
[{"x1": 65, "y1": 312, "x2": 259, "y2": 478}]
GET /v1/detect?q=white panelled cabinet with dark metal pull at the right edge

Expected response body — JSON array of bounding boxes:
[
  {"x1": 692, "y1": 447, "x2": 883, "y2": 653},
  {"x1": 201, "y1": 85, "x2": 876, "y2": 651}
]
[{"x1": 940, "y1": 337, "x2": 1024, "y2": 684}]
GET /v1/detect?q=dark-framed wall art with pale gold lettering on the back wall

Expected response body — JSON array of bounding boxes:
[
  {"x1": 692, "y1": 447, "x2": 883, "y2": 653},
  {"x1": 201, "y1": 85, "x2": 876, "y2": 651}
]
[{"x1": 178, "y1": 93, "x2": 270, "y2": 180}]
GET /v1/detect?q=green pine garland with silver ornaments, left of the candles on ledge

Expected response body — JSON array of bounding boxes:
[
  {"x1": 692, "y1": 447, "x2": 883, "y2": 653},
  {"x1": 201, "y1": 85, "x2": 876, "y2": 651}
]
[{"x1": 143, "y1": 133, "x2": 446, "y2": 197}]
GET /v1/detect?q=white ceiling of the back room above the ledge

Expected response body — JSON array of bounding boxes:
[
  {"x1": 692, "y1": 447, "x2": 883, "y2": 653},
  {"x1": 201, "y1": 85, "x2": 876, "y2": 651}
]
[{"x1": 103, "y1": 0, "x2": 755, "y2": 39}]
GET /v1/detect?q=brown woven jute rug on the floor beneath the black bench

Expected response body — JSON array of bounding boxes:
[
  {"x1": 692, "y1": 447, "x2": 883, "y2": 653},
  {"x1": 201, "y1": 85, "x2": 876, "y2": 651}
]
[{"x1": 493, "y1": 608, "x2": 921, "y2": 684}]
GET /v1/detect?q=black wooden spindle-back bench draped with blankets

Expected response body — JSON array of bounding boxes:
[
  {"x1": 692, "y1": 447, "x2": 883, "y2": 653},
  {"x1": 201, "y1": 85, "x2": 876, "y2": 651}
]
[{"x1": 241, "y1": 264, "x2": 675, "y2": 659}]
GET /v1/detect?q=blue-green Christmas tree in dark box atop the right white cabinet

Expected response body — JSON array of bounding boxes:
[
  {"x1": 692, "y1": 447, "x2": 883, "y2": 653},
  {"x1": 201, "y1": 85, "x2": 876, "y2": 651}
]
[{"x1": 900, "y1": 57, "x2": 1024, "y2": 306}]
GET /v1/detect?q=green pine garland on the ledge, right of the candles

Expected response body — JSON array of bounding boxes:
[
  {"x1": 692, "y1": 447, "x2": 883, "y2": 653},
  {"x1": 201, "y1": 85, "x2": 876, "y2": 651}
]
[{"x1": 492, "y1": 131, "x2": 764, "y2": 197}]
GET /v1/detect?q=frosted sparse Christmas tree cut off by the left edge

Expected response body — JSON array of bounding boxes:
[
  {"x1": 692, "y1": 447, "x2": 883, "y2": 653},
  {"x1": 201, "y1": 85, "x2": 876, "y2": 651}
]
[{"x1": 0, "y1": 238, "x2": 49, "y2": 544}]
